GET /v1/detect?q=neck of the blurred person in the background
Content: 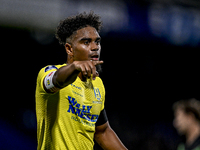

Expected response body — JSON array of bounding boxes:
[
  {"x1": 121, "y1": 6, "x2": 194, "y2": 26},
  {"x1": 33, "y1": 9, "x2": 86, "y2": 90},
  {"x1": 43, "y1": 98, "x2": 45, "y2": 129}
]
[{"x1": 186, "y1": 123, "x2": 200, "y2": 145}]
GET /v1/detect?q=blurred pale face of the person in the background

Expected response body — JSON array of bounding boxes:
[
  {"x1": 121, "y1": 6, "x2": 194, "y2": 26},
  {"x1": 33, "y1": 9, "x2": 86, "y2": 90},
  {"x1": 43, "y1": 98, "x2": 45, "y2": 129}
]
[{"x1": 173, "y1": 108, "x2": 191, "y2": 135}]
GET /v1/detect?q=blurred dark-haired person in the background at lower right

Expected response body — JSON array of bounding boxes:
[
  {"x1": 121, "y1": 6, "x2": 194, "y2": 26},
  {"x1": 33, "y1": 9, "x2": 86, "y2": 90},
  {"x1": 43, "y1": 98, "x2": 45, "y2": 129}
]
[{"x1": 173, "y1": 98, "x2": 200, "y2": 150}]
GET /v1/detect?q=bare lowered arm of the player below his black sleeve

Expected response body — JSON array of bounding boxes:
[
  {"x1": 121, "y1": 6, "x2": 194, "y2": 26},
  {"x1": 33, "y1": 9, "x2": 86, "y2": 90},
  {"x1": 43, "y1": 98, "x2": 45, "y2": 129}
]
[{"x1": 95, "y1": 127, "x2": 127, "y2": 150}]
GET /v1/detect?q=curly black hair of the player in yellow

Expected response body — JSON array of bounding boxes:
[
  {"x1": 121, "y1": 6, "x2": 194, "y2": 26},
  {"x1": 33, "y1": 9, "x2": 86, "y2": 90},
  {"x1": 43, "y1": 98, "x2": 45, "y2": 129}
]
[{"x1": 55, "y1": 11, "x2": 102, "y2": 45}]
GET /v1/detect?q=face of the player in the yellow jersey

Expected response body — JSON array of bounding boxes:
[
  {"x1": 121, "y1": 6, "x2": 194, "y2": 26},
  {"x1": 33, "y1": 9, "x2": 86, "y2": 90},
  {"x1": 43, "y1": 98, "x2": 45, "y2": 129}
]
[{"x1": 65, "y1": 26, "x2": 101, "y2": 62}]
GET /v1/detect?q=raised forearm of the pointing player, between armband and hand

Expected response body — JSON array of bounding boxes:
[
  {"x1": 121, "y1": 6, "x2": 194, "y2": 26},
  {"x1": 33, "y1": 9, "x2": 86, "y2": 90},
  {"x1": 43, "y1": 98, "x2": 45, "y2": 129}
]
[{"x1": 53, "y1": 63, "x2": 80, "y2": 88}]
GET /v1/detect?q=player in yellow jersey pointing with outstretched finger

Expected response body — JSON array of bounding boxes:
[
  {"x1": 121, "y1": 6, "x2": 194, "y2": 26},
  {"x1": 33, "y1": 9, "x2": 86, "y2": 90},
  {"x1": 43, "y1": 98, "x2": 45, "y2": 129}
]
[{"x1": 36, "y1": 12, "x2": 126, "y2": 150}]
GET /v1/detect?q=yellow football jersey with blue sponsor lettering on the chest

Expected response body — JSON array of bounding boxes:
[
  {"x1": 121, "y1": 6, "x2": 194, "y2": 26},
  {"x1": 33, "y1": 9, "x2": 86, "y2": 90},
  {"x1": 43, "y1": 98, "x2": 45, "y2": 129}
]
[{"x1": 36, "y1": 64, "x2": 105, "y2": 150}]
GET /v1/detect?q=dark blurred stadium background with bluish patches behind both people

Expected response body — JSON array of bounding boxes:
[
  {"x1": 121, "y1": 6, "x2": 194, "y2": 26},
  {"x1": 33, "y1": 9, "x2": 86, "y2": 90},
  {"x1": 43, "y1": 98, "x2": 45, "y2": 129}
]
[{"x1": 0, "y1": 0, "x2": 200, "y2": 150}]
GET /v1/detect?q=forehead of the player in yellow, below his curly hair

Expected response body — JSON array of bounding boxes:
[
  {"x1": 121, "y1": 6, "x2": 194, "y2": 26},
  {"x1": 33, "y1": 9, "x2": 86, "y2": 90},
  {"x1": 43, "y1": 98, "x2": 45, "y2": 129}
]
[{"x1": 74, "y1": 26, "x2": 100, "y2": 40}]
